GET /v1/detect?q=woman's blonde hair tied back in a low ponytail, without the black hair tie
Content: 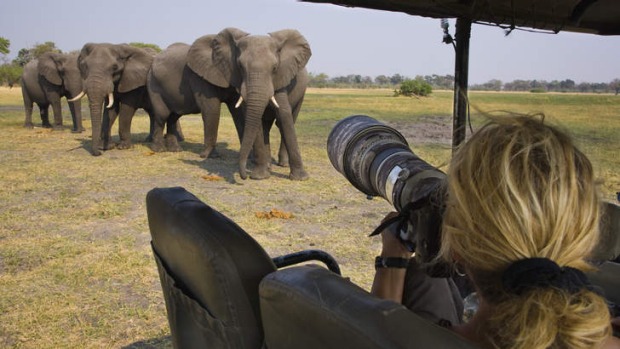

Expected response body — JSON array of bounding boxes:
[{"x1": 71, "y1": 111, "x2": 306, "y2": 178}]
[{"x1": 440, "y1": 115, "x2": 611, "y2": 349}]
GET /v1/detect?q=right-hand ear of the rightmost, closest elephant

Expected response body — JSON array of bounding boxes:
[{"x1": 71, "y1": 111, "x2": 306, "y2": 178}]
[{"x1": 269, "y1": 29, "x2": 312, "y2": 90}]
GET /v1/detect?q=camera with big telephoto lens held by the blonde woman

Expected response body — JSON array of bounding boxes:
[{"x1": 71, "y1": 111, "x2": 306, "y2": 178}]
[{"x1": 327, "y1": 115, "x2": 451, "y2": 277}]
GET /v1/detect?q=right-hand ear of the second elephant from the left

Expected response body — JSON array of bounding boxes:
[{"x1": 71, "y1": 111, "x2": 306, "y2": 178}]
[{"x1": 118, "y1": 44, "x2": 153, "y2": 93}]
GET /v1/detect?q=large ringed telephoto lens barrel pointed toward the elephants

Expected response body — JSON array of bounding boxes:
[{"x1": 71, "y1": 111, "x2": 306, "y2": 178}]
[{"x1": 327, "y1": 115, "x2": 445, "y2": 210}]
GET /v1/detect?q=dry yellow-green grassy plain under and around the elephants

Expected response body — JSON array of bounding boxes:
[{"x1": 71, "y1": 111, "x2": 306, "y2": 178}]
[{"x1": 0, "y1": 88, "x2": 620, "y2": 348}]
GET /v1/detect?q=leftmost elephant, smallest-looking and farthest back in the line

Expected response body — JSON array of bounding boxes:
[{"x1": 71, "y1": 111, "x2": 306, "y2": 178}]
[{"x1": 21, "y1": 52, "x2": 84, "y2": 132}]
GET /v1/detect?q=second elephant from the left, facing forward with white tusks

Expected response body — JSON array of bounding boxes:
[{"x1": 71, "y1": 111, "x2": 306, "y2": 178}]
[{"x1": 74, "y1": 43, "x2": 182, "y2": 156}]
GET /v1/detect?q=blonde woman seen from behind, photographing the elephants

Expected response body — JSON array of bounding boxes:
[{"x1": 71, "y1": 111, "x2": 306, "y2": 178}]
[{"x1": 372, "y1": 116, "x2": 620, "y2": 349}]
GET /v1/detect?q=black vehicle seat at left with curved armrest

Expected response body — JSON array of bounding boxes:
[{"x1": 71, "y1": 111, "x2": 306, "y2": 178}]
[{"x1": 146, "y1": 187, "x2": 339, "y2": 349}]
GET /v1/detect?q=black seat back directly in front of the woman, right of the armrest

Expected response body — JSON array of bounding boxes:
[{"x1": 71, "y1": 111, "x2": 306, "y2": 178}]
[{"x1": 259, "y1": 265, "x2": 475, "y2": 349}]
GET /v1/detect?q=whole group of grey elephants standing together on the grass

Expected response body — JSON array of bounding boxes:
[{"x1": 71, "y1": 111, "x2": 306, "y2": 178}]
[{"x1": 22, "y1": 28, "x2": 312, "y2": 180}]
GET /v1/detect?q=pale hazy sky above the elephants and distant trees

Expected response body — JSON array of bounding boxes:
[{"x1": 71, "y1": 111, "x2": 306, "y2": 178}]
[{"x1": 0, "y1": 0, "x2": 620, "y2": 84}]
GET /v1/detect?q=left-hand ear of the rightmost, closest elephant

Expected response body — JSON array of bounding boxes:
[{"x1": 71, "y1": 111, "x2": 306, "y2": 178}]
[{"x1": 187, "y1": 28, "x2": 249, "y2": 88}]
